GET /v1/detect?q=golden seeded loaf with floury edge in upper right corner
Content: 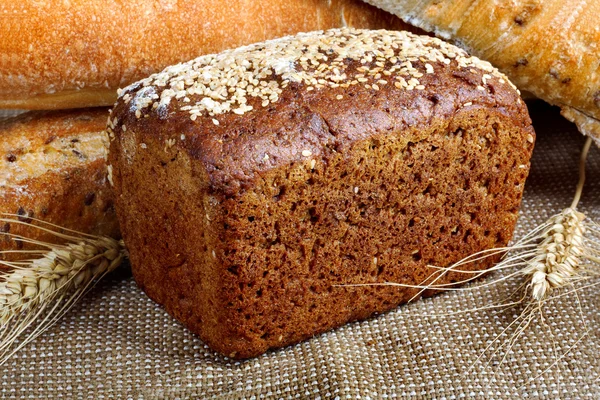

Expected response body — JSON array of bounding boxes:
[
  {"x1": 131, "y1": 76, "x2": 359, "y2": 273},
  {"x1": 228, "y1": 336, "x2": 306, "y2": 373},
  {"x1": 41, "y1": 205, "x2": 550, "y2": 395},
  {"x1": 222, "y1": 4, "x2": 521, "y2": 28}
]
[{"x1": 366, "y1": 0, "x2": 600, "y2": 145}]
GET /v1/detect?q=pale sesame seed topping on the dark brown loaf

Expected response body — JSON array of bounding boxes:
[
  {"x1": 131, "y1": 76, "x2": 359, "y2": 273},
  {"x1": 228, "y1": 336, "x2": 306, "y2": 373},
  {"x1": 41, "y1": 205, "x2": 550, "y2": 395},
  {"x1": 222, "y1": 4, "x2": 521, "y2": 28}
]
[{"x1": 120, "y1": 28, "x2": 514, "y2": 125}]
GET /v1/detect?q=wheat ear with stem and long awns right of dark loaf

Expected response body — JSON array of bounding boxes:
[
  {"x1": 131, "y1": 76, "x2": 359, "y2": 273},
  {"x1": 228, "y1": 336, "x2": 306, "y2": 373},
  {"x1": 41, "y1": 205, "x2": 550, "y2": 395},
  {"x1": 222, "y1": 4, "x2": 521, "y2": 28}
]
[{"x1": 335, "y1": 138, "x2": 600, "y2": 296}]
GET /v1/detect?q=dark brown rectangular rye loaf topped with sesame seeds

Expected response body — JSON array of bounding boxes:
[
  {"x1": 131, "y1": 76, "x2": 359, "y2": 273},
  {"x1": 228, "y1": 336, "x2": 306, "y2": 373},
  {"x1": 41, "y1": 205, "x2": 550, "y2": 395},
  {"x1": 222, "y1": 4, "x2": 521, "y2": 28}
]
[{"x1": 107, "y1": 30, "x2": 534, "y2": 358}]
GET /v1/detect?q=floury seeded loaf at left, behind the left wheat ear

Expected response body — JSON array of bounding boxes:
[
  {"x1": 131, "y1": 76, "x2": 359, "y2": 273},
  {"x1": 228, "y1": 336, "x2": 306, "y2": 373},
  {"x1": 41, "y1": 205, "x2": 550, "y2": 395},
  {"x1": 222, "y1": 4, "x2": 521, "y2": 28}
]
[{"x1": 0, "y1": 108, "x2": 119, "y2": 260}]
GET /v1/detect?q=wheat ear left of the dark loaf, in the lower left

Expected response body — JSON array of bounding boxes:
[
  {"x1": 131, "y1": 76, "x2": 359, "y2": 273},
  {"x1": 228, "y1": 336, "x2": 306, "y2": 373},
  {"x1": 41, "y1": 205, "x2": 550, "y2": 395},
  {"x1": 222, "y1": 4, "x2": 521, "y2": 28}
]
[{"x1": 0, "y1": 214, "x2": 126, "y2": 365}]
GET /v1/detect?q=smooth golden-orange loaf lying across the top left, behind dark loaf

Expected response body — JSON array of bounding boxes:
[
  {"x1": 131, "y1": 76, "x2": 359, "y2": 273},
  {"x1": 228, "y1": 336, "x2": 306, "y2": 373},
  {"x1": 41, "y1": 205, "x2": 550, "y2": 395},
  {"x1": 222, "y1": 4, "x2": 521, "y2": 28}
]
[{"x1": 0, "y1": 0, "x2": 405, "y2": 109}]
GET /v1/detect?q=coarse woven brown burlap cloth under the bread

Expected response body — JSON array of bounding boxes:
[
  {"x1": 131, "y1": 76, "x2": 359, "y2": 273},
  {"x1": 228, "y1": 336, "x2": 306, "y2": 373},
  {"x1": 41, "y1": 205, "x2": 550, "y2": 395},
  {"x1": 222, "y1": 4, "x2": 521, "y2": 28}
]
[{"x1": 0, "y1": 104, "x2": 600, "y2": 399}]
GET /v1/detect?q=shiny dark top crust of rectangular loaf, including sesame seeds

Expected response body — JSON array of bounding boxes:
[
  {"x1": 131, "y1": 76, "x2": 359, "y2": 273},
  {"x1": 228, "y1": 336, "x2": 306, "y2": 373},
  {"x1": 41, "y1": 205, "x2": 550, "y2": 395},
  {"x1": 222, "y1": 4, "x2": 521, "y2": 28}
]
[{"x1": 108, "y1": 29, "x2": 532, "y2": 195}]
